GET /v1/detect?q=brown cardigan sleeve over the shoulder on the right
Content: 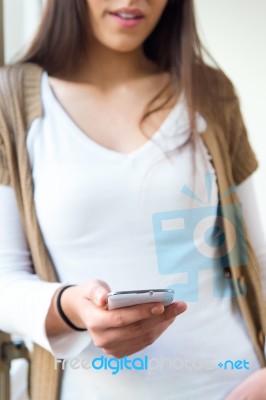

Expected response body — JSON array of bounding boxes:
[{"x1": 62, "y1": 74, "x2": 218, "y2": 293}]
[{"x1": 196, "y1": 66, "x2": 258, "y2": 184}]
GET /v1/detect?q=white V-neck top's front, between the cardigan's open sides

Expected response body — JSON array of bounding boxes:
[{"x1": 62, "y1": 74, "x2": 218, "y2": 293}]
[{"x1": 0, "y1": 73, "x2": 260, "y2": 400}]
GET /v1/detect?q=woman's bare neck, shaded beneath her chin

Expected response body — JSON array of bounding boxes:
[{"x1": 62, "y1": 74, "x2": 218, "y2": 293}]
[{"x1": 72, "y1": 42, "x2": 159, "y2": 89}]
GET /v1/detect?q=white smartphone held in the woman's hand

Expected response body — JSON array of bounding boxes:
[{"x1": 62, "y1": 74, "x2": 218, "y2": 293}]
[{"x1": 106, "y1": 289, "x2": 174, "y2": 310}]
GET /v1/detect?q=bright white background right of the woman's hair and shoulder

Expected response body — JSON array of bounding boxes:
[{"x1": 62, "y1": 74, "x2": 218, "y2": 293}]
[{"x1": 195, "y1": 0, "x2": 266, "y2": 231}]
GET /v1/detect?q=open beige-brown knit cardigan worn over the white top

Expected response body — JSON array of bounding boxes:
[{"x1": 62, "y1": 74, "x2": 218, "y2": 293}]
[{"x1": 0, "y1": 64, "x2": 266, "y2": 400}]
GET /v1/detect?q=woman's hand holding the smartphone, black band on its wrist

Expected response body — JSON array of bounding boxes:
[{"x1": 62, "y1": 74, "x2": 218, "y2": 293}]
[{"x1": 48, "y1": 280, "x2": 187, "y2": 358}]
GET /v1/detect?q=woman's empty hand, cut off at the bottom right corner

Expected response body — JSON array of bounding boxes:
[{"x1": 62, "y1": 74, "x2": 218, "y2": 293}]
[{"x1": 226, "y1": 368, "x2": 266, "y2": 400}]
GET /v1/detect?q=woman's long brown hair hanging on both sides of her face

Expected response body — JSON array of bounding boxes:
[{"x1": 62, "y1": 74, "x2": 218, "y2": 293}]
[{"x1": 20, "y1": 0, "x2": 233, "y2": 130}]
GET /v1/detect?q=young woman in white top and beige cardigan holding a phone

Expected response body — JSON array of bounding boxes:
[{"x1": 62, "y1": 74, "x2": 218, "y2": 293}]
[{"x1": 0, "y1": 0, "x2": 266, "y2": 400}]
